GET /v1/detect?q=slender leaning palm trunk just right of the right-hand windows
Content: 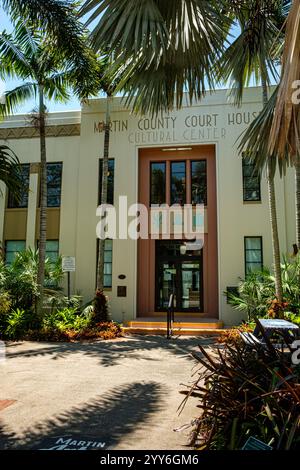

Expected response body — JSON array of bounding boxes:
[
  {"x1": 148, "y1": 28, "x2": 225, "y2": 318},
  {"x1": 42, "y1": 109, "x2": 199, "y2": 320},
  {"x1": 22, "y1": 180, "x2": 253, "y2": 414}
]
[{"x1": 262, "y1": 78, "x2": 283, "y2": 302}]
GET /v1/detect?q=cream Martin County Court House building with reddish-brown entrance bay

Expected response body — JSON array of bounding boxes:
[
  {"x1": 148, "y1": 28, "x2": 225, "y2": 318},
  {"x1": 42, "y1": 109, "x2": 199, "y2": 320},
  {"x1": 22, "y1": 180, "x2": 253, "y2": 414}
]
[{"x1": 0, "y1": 88, "x2": 296, "y2": 325}]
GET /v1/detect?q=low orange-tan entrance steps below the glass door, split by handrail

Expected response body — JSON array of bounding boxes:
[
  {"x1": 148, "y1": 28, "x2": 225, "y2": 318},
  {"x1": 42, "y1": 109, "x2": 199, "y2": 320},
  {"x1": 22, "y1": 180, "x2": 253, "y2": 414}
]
[{"x1": 123, "y1": 315, "x2": 224, "y2": 336}]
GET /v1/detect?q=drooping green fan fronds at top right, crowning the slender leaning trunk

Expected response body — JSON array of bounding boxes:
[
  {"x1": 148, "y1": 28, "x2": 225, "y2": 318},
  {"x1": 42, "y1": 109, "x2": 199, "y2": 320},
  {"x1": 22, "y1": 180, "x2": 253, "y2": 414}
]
[{"x1": 216, "y1": 0, "x2": 283, "y2": 104}]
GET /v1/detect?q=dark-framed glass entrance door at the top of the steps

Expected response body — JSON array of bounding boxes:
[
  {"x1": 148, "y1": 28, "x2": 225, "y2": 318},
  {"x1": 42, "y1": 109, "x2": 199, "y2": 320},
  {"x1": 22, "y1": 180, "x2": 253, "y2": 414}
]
[{"x1": 155, "y1": 240, "x2": 203, "y2": 312}]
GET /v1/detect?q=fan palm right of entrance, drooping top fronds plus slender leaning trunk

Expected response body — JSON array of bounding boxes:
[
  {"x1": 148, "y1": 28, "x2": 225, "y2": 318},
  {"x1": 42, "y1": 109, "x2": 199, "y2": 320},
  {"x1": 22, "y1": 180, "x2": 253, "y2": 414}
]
[{"x1": 218, "y1": 0, "x2": 284, "y2": 302}]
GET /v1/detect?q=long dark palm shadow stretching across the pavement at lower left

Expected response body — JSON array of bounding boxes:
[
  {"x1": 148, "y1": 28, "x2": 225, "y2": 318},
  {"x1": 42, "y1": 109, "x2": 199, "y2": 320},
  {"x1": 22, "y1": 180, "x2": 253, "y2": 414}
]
[{"x1": 0, "y1": 382, "x2": 166, "y2": 450}]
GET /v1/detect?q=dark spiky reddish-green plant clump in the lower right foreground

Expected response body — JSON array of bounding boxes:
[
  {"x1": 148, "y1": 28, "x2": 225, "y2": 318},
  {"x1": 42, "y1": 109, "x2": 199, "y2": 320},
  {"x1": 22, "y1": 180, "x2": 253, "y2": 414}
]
[{"x1": 182, "y1": 332, "x2": 300, "y2": 450}]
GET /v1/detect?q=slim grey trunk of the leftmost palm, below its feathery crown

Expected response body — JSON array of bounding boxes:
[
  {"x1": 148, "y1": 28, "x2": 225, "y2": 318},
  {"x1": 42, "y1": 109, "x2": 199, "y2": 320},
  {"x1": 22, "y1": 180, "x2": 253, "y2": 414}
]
[{"x1": 37, "y1": 85, "x2": 47, "y2": 317}]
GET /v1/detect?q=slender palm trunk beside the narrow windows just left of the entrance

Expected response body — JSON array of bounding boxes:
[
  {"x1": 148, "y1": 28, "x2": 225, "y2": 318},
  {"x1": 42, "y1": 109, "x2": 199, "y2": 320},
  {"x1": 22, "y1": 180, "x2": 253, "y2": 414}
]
[{"x1": 97, "y1": 95, "x2": 111, "y2": 292}]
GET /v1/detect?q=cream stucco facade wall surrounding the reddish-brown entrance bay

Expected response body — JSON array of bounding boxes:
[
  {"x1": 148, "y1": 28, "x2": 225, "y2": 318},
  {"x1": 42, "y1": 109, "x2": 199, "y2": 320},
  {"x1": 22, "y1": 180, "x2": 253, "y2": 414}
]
[{"x1": 0, "y1": 92, "x2": 295, "y2": 324}]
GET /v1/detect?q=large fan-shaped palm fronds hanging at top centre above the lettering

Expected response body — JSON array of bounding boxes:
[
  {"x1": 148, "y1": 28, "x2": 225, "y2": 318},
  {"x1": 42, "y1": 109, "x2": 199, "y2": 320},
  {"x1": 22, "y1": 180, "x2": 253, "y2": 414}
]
[{"x1": 80, "y1": 0, "x2": 230, "y2": 113}]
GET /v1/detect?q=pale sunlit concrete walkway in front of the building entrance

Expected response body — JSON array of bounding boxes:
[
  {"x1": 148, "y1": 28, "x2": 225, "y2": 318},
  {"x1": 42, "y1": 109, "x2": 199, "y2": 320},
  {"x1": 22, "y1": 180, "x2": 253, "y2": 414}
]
[{"x1": 0, "y1": 336, "x2": 212, "y2": 450}]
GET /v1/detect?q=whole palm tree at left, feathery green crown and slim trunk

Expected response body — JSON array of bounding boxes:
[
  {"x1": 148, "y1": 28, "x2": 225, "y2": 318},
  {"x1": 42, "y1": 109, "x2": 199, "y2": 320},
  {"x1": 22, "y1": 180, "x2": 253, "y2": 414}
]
[{"x1": 0, "y1": 21, "x2": 98, "y2": 315}]
